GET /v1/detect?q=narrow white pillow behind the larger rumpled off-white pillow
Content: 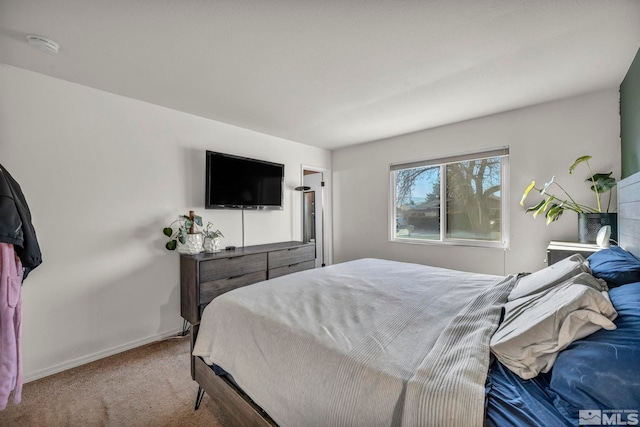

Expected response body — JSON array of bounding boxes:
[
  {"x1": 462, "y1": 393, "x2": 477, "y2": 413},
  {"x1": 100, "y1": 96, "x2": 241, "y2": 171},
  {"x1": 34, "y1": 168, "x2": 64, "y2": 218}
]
[{"x1": 507, "y1": 254, "x2": 591, "y2": 301}]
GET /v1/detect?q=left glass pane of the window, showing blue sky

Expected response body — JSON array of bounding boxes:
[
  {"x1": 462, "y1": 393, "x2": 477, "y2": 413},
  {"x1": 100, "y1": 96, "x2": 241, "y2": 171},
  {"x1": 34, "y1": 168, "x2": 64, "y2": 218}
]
[{"x1": 394, "y1": 166, "x2": 440, "y2": 240}]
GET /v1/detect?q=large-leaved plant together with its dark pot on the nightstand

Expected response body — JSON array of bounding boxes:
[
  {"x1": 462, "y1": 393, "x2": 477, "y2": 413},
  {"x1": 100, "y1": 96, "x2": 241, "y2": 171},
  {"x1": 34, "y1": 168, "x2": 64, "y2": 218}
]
[{"x1": 520, "y1": 156, "x2": 617, "y2": 243}]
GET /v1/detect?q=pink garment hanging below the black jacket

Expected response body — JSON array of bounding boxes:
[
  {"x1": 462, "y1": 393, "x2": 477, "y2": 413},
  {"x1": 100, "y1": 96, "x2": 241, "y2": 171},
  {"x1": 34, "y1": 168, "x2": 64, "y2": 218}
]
[{"x1": 0, "y1": 243, "x2": 22, "y2": 410}]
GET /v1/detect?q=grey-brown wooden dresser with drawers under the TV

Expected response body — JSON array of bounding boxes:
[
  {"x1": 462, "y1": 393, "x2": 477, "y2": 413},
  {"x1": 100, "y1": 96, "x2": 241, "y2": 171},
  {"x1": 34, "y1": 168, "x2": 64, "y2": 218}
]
[{"x1": 180, "y1": 242, "x2": 315, "y2": 325}]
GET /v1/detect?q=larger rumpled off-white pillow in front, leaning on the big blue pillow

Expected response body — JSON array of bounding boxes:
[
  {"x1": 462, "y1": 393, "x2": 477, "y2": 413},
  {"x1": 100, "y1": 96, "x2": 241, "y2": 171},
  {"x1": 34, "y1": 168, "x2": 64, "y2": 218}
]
[{"x1": 491, "y1": 273, "x2": 618, "y2": 379}]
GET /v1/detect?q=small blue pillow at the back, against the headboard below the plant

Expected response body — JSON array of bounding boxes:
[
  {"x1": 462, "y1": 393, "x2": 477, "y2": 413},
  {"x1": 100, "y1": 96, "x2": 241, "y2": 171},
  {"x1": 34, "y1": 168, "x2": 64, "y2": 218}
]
[{"x1": 587, "y1": 246, "x2": 640, "y2": 288}]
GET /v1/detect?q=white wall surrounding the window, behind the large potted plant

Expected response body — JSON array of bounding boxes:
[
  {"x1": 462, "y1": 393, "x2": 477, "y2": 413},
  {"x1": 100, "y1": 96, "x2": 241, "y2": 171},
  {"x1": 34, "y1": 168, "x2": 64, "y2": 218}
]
[{"x1": 332, "y1": 89, "x2": 620, "y2": 274}]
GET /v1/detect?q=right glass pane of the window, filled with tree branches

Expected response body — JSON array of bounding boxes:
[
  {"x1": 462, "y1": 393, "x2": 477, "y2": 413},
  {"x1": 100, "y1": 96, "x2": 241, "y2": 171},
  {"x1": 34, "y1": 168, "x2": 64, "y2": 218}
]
[{"x1": 445, "y1": 157, "x2": 502, "y2": 241}]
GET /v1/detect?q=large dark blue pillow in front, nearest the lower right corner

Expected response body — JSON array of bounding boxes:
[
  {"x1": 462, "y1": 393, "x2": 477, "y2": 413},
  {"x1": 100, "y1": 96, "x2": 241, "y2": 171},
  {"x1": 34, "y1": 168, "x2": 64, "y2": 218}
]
[{"x1": 550, "y1": 283, "x2": 640, "y2": 425}]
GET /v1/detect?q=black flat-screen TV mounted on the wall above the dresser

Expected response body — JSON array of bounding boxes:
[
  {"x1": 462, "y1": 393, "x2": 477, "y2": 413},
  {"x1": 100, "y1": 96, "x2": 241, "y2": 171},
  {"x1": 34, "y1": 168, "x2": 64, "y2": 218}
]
[{"x1": 205, "y1": 151, "x2": 284, "y2": 210}]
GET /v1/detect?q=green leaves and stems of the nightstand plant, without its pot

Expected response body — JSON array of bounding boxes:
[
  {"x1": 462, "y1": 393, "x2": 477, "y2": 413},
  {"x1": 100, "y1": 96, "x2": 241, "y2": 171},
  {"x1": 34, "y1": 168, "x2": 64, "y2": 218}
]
[{"x1": 520, "y1": 156, "x2": 616, "y2": 225}]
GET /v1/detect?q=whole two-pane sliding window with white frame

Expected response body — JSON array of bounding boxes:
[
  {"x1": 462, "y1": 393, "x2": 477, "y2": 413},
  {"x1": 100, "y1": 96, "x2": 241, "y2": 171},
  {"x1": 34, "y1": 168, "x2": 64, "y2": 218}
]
[{"x1": 390, "y1": 147, "x2": 509, "y2": 248}]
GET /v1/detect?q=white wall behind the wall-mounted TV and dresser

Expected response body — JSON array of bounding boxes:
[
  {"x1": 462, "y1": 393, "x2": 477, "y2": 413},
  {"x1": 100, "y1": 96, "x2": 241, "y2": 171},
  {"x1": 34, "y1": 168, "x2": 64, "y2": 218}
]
[{"x1": 0, "y1": 64, "x2": 331, "y2": 380}]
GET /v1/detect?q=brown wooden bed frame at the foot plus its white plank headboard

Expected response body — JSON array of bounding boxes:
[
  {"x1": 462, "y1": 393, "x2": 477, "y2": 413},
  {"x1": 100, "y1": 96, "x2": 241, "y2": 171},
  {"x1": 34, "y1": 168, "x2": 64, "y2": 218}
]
[{"x1": 181, "y1": 172, "x2": 640, "y2": 426}]
